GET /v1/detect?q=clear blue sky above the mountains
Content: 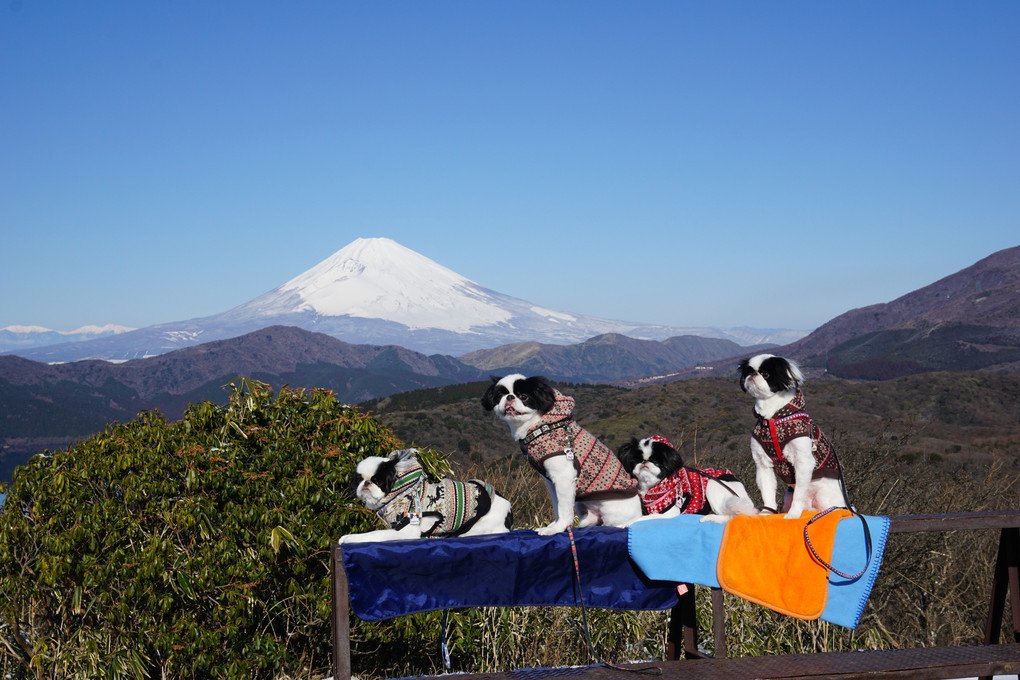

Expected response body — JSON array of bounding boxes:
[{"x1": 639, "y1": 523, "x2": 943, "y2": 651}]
[{"x1": 0, "y1": 0, "x2": 1020, "y2": 330}]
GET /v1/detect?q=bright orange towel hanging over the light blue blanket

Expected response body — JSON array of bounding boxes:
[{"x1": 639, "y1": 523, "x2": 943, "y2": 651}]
[{"x1": 717, "y1": 510, "x2": 850, "y2": 620}]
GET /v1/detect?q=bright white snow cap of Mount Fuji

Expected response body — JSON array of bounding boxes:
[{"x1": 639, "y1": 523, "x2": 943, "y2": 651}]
[{"x1": 259, "y1": 239, "x2": 511, "y2": 332}]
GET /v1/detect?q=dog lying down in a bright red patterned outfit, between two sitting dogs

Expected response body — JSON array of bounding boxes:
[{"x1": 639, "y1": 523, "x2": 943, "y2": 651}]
[{"x1": 616, "y1": 435, "x2": 757, "y2": 523}]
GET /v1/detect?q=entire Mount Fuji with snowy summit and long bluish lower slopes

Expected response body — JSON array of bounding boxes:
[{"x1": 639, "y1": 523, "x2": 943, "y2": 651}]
[{"x1": 9, "y1": 239, "x2": 804, "y2": 363}]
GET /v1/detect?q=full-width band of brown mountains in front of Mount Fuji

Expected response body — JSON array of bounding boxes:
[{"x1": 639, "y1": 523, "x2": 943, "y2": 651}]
[{"x1": 0, "y1": 242, "x2": 1020, "y2": 480}]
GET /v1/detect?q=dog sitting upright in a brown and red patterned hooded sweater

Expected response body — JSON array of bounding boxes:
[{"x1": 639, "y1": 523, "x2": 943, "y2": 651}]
[{"x1": 481, "y1": 373, "x2": 642, "y2": 536}]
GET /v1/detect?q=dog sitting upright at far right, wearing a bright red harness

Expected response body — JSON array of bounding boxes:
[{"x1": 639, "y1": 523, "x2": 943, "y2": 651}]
[{"x1": 741, "y1": 354, "x2": 846, "y2": 519}]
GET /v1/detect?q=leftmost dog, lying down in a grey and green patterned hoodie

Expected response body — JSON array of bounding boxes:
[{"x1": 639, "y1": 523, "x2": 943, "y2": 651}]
[{"x1": 340, "y1": 449, "x2": 513, "y2": 543}]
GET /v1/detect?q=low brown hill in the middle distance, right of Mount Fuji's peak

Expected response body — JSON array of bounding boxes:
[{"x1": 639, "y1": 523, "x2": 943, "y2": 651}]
[{"x1": 459, "y1": 333, "x2": 774, "y2": 382}]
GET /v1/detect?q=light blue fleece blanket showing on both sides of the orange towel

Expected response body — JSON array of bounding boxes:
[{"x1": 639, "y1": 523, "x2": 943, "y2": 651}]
[{"x1": 628, "y1": 515, "x2": 889, "y2": 628}]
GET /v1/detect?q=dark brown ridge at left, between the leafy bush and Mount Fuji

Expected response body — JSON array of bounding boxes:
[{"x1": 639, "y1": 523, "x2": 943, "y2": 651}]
[{"x1": 0, "y1": 326, "x2": 486, "y2": 480}]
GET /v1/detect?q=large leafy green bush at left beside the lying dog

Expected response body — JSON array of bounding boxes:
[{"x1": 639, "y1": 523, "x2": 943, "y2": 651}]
[{"x1": 0, "y1": 379, "x2": 442, "y2": 678}]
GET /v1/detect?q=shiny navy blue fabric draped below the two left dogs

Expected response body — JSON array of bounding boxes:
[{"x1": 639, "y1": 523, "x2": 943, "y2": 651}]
[{"x1": 342, "y1": 527, "x2": 677, "y2": 621}]
